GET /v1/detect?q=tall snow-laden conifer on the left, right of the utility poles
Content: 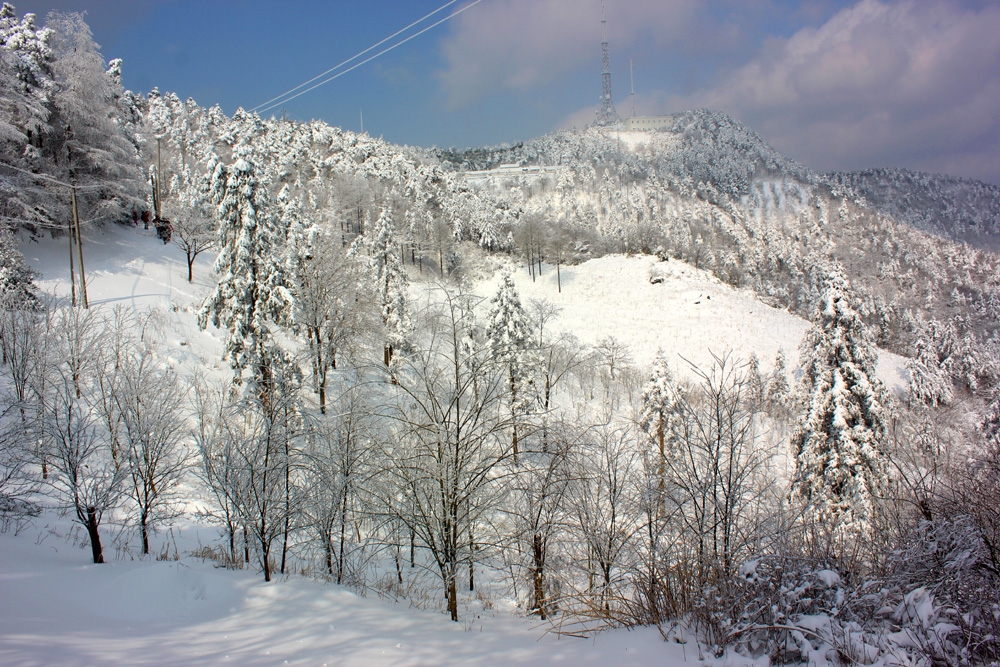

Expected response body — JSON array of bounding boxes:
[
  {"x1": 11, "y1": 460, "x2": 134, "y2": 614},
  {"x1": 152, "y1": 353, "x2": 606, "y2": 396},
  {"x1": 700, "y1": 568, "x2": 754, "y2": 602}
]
[{"x1": 198, "y1": 145, "x2": 295, "y2": 396}]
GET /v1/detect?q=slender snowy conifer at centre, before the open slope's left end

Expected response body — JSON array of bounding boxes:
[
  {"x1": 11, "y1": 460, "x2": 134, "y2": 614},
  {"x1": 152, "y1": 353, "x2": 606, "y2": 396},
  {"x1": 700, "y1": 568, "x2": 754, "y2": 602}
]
[{"x1": 486, "y1": 271, "x2": 534, "y2": 461}]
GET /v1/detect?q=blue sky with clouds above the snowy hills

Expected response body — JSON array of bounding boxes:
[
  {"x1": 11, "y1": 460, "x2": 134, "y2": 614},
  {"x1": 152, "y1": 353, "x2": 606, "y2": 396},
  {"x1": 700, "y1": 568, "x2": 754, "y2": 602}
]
[{"x1": 14, "y1": 0, "x2": 1000, "y2": 184}]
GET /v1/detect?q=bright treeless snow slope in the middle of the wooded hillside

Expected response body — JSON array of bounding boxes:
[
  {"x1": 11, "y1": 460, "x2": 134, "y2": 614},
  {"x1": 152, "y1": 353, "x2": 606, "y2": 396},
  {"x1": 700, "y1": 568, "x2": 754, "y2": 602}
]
[{"x1": 479, "y1": 255, "x2": 907, "y2": 389}]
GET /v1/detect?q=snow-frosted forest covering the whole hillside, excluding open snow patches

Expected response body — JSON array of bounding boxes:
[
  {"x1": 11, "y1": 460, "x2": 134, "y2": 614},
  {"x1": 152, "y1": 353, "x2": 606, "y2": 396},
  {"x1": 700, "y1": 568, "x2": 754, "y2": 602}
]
[{"x1": 0, "y1": 4, "x2": 1000, "y2": 664}]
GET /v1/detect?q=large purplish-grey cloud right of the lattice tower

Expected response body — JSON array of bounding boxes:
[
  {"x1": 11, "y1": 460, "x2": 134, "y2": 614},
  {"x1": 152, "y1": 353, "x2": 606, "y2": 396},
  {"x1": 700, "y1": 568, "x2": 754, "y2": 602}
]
[{"x1": 659, "y1": 0, "x2": 1000, "y2": 182}]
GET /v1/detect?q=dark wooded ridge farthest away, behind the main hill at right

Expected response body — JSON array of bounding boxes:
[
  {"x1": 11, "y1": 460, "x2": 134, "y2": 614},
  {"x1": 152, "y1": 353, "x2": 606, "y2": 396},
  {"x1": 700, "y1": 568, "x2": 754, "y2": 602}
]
[{"x1": 827, "y1": 169, "x2": 1000, "y2": 251}]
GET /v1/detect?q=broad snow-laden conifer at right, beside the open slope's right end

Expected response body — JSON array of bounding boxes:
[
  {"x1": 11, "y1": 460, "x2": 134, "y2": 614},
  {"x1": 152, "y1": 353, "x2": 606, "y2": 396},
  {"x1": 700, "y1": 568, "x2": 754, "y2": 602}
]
[{"x1": 791, "y1": 272, "x2": 889, "y2": 535}]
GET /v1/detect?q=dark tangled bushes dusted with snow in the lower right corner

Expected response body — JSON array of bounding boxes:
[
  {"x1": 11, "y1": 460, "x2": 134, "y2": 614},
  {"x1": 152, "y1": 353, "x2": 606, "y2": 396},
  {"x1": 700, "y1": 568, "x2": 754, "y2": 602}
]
[{"x1": 704, "y1": 516, "x2": 1000, "y2": 665}]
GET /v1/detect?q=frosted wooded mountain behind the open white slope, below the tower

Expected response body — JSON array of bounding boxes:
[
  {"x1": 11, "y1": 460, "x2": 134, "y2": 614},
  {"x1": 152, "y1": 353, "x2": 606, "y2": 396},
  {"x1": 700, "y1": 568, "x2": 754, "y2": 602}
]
[{"x1": 436, "y1": 109, "x2": 1000, "y2": 390}]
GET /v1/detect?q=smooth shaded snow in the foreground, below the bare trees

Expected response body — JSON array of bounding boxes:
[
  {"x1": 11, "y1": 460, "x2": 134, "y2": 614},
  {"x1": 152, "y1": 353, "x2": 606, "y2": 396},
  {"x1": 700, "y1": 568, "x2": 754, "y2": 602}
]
[{"x1": 0, "y1": 520, "x2": 697, "y2": 667}]
